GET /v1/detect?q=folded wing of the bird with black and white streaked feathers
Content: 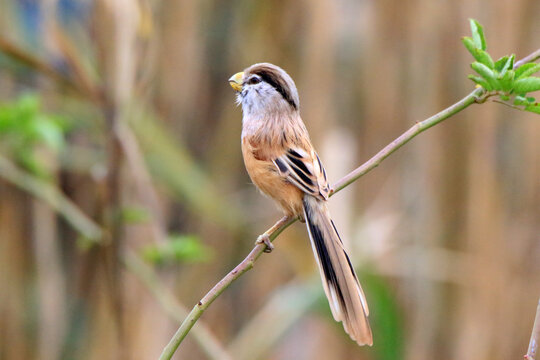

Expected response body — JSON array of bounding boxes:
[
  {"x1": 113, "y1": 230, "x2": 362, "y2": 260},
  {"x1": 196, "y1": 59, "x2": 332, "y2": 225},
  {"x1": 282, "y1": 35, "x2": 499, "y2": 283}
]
[{"x1": 272, "y1": 147, "x2": 330, "y2": 200}]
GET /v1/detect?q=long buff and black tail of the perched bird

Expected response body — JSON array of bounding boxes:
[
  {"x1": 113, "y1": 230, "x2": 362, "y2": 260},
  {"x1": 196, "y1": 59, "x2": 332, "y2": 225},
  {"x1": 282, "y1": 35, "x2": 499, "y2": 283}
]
[{"x1": 304, "y1": 195, "x2": 373, "y2": 346}]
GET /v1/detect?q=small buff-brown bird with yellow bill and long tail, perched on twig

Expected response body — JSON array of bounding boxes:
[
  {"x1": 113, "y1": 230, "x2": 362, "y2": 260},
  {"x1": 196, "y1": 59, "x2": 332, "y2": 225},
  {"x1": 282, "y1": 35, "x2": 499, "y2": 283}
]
[{"x1": 229, "y1": 63, "x2": 373, "y2": 346}]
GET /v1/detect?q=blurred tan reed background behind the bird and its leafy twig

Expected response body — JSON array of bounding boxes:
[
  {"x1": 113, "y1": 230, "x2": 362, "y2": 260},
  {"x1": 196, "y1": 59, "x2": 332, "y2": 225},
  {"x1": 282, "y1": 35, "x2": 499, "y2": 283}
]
[{"x1": 0, "y1": 0, "x2": 540, "y2": 360}]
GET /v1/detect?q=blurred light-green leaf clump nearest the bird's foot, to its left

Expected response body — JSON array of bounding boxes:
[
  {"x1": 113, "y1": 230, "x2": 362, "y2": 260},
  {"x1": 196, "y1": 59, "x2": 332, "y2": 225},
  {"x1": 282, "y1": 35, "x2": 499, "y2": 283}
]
[{"x1": 142, "y1": 234, "x2": 213, "y2": 265}]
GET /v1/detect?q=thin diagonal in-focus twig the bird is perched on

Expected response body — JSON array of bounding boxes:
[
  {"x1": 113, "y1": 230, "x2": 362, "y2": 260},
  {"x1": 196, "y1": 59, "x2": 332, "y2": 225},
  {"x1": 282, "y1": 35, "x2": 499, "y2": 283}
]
[{"x1": 159, "y1": 88, "x2": 484, "y2": 360}]
